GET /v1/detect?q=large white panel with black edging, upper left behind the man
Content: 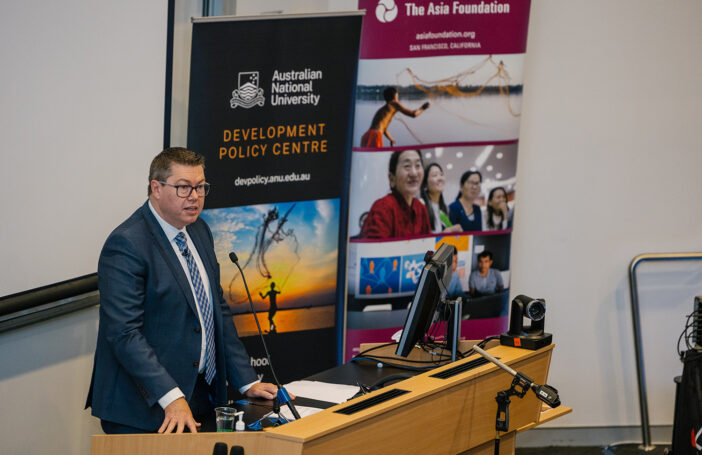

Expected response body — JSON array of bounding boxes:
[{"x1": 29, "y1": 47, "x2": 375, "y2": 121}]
[{"x1": 0, "y1": 0, "x2": 167, "y2": 296}]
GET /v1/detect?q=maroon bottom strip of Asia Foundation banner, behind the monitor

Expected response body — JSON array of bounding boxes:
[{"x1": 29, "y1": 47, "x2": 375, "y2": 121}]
[{"x1": 344, "y1": 317, "x2": 508, "y2": 361}]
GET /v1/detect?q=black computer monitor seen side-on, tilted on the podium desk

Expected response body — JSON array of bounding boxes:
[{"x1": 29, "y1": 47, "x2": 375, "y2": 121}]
[{"x1": 395, "y1": 243, "x2": 456, "y2": 357}]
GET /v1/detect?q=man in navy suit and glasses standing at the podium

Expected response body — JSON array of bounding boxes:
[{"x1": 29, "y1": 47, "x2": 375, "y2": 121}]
[{"x1": 86, "y1": 148, "x2": 277, "y2": 433}]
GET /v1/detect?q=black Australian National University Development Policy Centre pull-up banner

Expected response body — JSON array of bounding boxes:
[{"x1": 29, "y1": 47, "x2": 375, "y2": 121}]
[{"x1": 188, "y1": 12, "x2": 362, "y2": 382}]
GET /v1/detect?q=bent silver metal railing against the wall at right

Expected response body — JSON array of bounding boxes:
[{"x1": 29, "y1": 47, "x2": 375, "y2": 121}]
[{"x1": 629, "y1": 253, "x2": 702, "y2": 452}]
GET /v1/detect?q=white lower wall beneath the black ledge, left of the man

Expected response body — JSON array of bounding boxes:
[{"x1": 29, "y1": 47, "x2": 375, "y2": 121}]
[{"x1": 0, "y1": 307, "x2": 102, "y2": 455}]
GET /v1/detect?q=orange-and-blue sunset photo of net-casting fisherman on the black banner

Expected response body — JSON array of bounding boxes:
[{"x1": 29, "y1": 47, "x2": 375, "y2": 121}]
[{"x1": 202, "y1": 199, "x2": 339, "y2": 336}]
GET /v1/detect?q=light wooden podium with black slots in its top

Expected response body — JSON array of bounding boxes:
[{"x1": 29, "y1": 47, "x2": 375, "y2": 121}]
[{"x1": 91, "y1": 345, "x2": 571, "y2": 455}]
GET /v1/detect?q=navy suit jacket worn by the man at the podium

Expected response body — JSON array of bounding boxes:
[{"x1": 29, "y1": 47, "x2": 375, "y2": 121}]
[{"x1": 86, "y1": 202, "x2": 257, "y2": 431}]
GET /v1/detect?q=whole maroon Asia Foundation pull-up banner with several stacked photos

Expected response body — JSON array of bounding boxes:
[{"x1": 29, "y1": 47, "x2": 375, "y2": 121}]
[{"x1": 344, "y1": 0, "x2": 530, "y2": 360}]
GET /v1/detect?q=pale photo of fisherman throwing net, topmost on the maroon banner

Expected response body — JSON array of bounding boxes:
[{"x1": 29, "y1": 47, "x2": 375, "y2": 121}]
[{"x1": 354, "y1": 55, "x2": 522, "y2": 148}]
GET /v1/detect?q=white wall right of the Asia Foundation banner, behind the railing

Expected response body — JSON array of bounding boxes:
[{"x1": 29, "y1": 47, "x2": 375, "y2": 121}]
[{"x1": 511, "y1": 0, "x2": 702, "y2": 432}]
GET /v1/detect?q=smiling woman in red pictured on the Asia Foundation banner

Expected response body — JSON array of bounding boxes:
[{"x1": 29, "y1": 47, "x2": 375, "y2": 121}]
[{"x1": 361, "y1": 150, "x2": 431, "y2": 239}]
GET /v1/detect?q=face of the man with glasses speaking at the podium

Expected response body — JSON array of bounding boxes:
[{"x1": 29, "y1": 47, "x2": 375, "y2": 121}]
[{"x1": 151, "y1": 163, "x2": 205, "y2": 229}]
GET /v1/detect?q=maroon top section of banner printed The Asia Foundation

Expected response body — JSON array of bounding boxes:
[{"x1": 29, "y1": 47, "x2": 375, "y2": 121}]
[{"x1": 359, "y1": 0, "x2": 531, "y2": 59}]
